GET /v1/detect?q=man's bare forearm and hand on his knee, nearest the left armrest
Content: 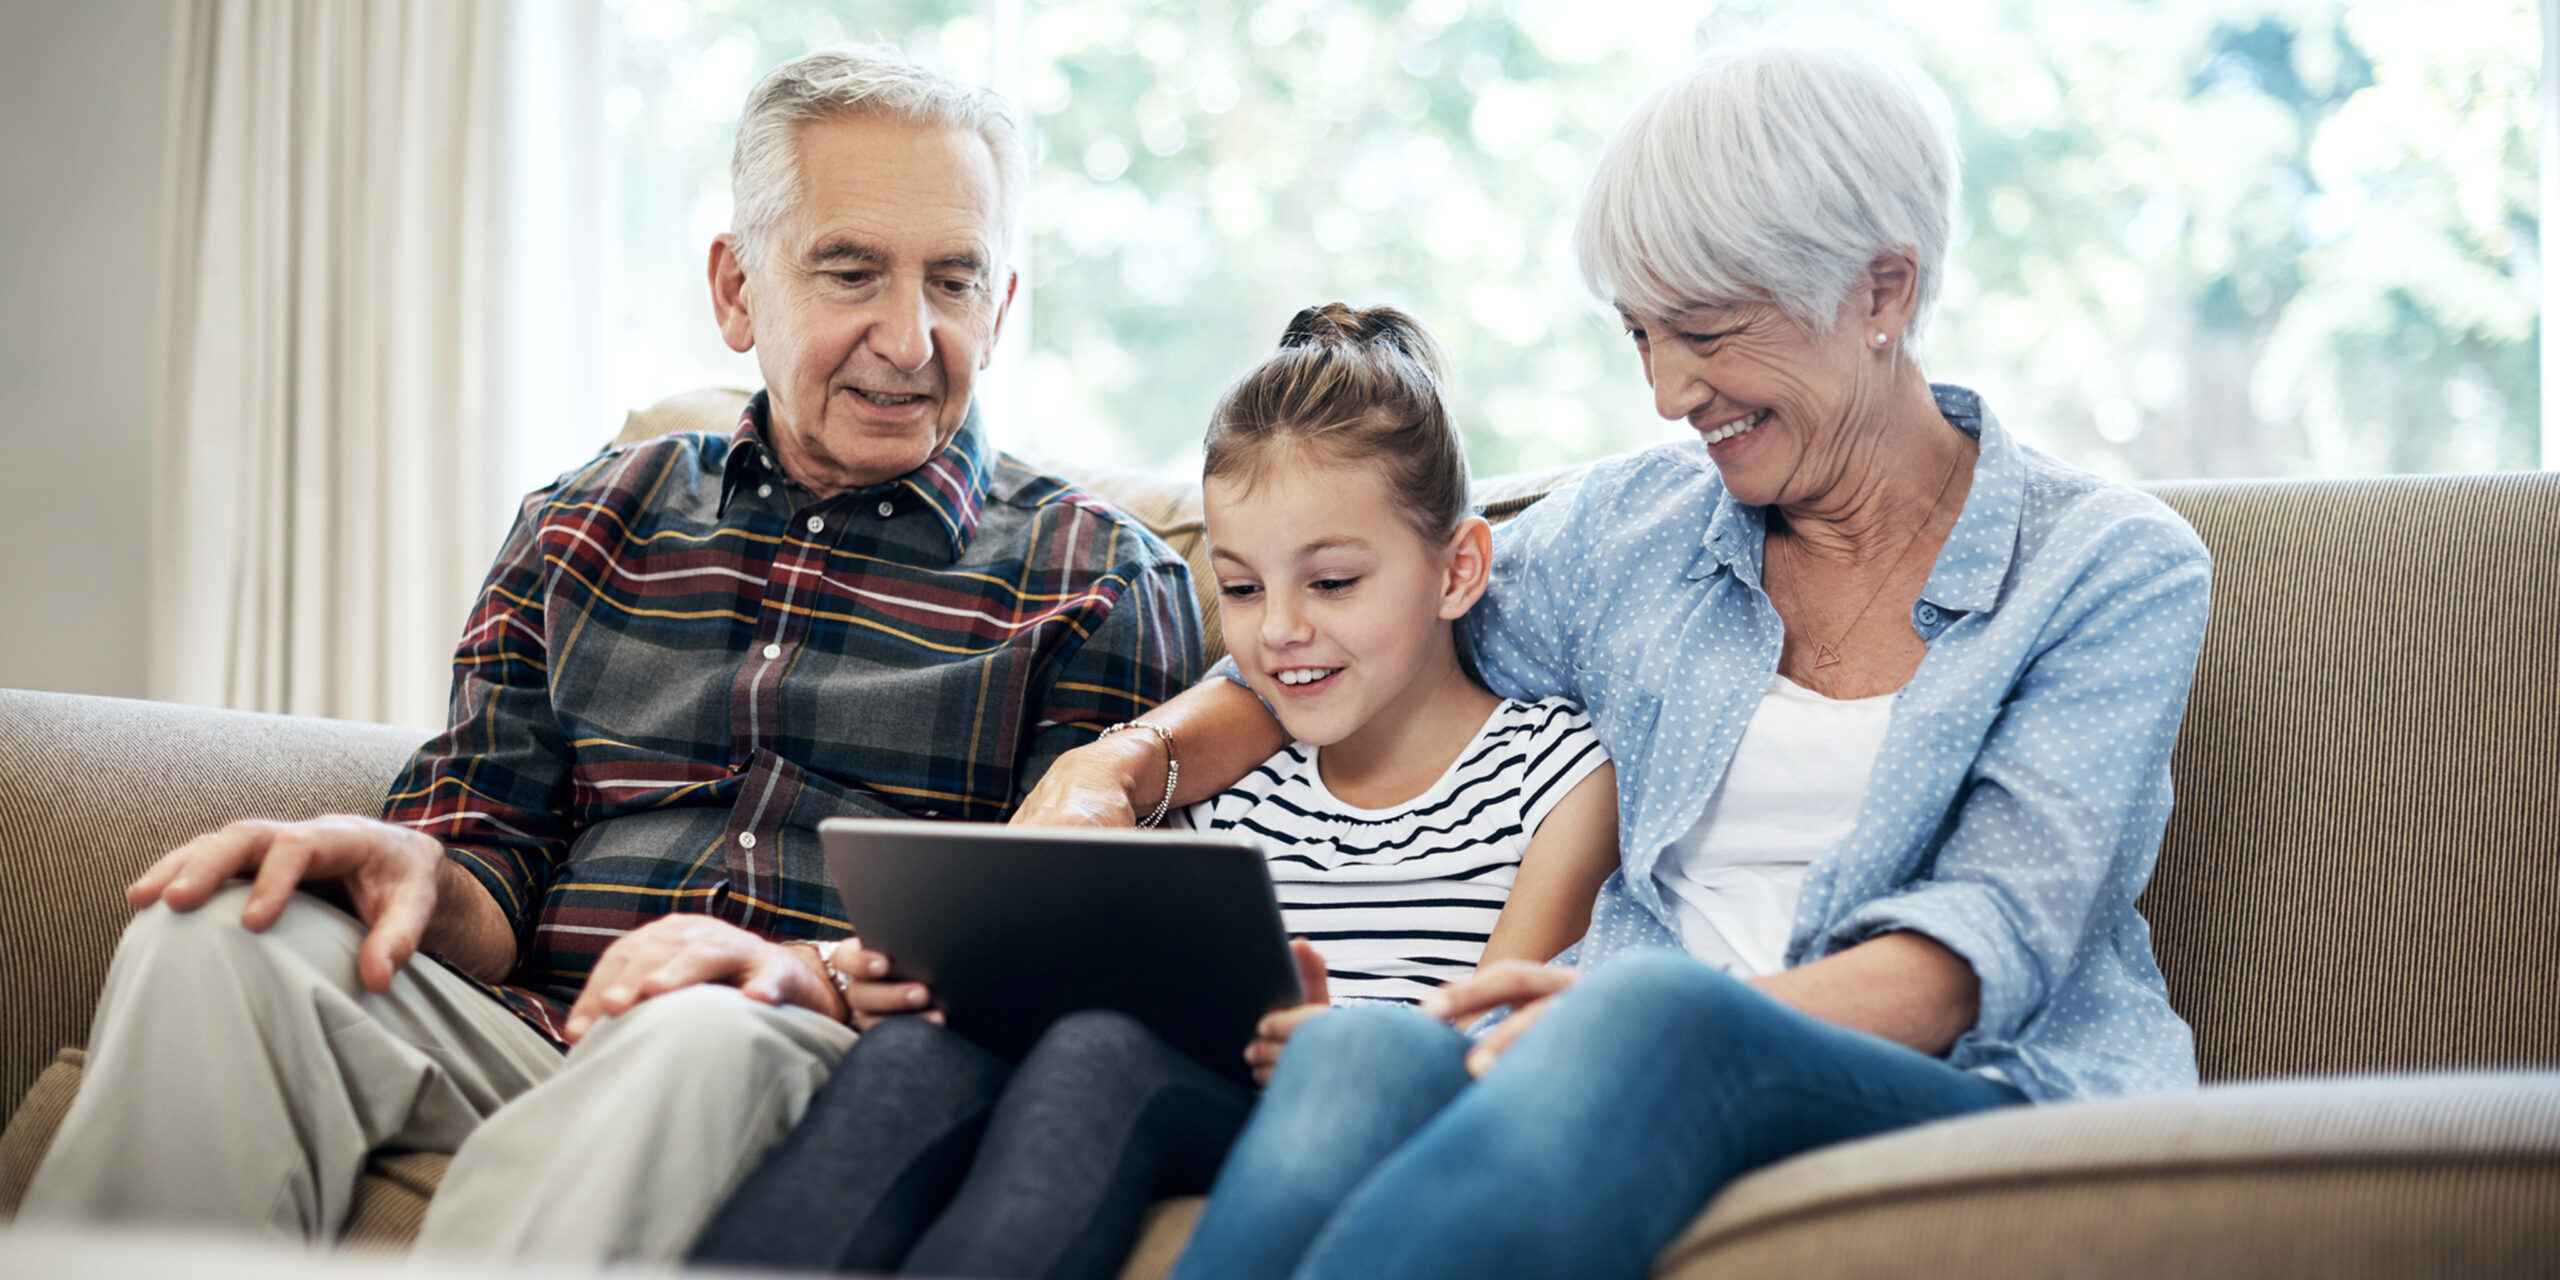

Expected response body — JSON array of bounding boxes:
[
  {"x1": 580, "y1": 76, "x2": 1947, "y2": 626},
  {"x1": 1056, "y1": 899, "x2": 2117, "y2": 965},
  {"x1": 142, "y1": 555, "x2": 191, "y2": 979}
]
[{"x1": 125, "y1": 814, "x2": 515, "y2": 991}]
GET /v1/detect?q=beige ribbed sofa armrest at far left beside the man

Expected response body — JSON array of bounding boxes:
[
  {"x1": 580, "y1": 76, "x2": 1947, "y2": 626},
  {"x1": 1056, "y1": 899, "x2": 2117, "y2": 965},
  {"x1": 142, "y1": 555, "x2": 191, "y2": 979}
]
[{"x1": 0, "y1": 689, "x2": 425, "y2": 1116}]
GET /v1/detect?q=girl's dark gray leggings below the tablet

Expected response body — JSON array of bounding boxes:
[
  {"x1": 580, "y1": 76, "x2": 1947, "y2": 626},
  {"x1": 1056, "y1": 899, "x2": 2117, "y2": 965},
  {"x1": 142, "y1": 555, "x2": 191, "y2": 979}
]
[{"x1": 694, "y1": 1011, "x2": 1254, "y2": 1280}]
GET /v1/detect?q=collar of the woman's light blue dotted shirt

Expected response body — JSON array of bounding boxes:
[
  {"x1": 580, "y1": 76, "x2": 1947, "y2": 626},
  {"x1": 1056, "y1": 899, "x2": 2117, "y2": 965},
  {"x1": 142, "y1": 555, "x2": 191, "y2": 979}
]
[{"x1": 1690, "y1": 381, "x2": 2028, "y2": 614}]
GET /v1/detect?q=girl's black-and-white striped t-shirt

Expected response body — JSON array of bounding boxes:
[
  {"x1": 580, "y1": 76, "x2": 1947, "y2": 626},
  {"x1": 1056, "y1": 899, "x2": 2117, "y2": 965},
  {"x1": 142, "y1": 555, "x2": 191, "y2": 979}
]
[{"x1": 1183, "y1": 699, "x2": 1608, "y2": 1004}]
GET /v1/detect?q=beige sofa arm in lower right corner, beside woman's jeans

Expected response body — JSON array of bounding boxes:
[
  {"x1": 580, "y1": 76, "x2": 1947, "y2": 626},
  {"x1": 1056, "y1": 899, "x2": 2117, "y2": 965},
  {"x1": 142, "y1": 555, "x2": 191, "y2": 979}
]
[{"x1": 1656, "y1": 1073, "x2": 2560, "y2": 1280}]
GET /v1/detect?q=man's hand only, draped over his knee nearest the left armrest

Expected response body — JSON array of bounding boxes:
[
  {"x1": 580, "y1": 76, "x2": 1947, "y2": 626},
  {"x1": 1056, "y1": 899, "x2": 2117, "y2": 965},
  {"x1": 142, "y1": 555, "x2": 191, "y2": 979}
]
[{"x1": 125, "y1": 814, "x2": 445, "y2": 991}]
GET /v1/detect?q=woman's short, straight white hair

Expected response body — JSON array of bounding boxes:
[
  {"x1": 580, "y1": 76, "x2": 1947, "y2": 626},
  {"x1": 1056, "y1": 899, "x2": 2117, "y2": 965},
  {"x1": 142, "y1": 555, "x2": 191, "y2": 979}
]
[{"x1": 1574, "y1": 38, "x2": 1958, "y2": 338}]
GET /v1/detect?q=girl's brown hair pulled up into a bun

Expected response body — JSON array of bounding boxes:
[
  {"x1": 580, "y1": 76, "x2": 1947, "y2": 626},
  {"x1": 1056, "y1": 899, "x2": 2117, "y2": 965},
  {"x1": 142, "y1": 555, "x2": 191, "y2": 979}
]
[{"x1": 1201, "y1": 302, "x2": 1469, "y2": 543}]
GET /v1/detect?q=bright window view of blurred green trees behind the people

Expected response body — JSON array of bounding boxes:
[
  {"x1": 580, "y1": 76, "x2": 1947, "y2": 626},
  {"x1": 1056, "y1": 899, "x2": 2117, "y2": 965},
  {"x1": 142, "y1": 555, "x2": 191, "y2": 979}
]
[{"x1": 609, "y1": 0, "x2": 2542, "y2": 479}]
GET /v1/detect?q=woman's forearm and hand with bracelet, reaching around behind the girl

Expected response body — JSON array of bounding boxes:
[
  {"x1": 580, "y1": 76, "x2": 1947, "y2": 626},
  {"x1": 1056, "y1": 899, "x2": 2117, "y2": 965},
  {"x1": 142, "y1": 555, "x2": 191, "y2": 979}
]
[{"x1": 1014, "y1": 676, "x2": 1288, "y2": 827}]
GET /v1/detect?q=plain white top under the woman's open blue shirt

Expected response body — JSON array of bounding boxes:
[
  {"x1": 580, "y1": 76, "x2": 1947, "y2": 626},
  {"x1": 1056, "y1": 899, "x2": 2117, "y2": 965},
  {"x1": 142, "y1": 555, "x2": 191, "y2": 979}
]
[{"x1": 1654, "y1": 676, "x2": 1894, "y2": 975}]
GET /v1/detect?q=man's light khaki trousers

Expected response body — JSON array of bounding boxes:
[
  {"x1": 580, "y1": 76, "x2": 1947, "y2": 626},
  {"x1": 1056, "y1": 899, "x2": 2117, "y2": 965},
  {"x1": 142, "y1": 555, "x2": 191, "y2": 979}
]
[{"x1": 20, "y1": 886, "x2": 852, "y2": 1260}]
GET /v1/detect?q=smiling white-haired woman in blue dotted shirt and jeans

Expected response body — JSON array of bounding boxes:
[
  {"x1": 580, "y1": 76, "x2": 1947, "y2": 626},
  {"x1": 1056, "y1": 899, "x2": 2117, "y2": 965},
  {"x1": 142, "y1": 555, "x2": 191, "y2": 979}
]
[{"x1": 1024, "y1": 30, "x2": 2209, "y2": 1277}]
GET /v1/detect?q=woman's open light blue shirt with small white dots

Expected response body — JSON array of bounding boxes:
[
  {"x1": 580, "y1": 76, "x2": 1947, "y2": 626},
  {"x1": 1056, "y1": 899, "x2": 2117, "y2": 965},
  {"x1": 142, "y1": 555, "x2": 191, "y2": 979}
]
[{"x1": 1464, "y1": 387, "x2": 2212, "y2": 1098}]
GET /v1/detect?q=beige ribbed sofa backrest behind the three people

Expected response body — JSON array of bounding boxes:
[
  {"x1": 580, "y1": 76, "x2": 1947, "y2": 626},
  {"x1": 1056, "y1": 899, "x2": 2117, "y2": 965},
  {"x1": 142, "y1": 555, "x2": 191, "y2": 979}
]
[{"x1": 622, "y1": 392, "x2": 2560, "y2": 1080}]
